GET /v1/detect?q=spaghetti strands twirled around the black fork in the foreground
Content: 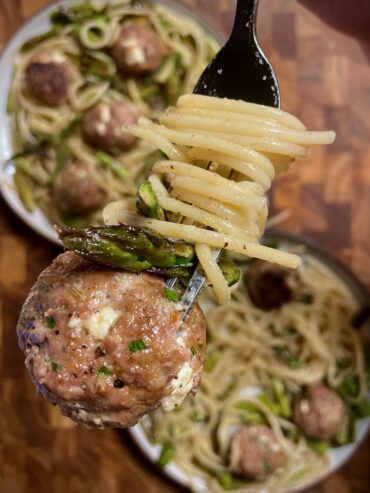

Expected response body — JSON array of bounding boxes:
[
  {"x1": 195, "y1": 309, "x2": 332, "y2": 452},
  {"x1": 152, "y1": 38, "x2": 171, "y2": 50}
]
[{"x1": 105, "y1": 95, "x2": 335, "y2": 303}]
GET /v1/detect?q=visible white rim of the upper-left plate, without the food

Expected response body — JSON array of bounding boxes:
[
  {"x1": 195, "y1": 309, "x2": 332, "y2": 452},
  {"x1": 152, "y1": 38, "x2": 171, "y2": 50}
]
[{"x1": 0, "y1": 0, "x2": 224, "y2": 244}]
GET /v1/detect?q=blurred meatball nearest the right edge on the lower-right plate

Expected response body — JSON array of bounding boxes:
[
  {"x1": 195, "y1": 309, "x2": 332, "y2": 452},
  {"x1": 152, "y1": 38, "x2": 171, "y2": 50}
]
[{"x1": 293, "y1": 385, "x2": 346, "y2": 440}]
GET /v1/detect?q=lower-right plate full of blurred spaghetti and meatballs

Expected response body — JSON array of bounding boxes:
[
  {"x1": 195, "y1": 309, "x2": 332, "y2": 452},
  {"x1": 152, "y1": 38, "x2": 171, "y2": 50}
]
[{"x1": 130, "y1": 233, "x2": 369, "y2": 493}]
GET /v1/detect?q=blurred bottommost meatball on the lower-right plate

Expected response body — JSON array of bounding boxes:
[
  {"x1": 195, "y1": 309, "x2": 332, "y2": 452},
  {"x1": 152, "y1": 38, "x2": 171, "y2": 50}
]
[{"x1": 231, "y1": 425, "x2": 285, "y2": 480}]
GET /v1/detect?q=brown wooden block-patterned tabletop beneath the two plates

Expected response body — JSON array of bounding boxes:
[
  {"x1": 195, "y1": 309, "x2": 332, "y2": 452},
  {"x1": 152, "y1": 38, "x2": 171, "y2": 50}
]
[{"x1": 0, "y1": 0, "x2": 370, "y2": 493}]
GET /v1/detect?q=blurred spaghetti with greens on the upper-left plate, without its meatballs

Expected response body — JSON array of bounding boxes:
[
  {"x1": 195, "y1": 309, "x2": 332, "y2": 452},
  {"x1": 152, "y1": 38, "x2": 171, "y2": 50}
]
[{"x1": 8, "y1": 0, "x2": 217, "y2": 226}]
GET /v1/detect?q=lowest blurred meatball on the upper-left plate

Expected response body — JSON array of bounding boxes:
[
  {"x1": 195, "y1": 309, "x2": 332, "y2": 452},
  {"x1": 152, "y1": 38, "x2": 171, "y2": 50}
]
[{"x1": 52, "y1": 162, "x2": 107, "y2": 215}]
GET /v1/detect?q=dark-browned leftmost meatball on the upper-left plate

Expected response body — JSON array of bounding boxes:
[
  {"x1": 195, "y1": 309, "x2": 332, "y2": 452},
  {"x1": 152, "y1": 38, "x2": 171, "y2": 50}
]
[{"x1": 25, "y1": 54, "x2": 72, "y2": 106}]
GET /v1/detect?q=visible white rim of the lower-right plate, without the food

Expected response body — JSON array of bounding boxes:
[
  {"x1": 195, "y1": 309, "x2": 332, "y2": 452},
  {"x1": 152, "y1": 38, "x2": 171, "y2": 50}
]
[{"x1": 129, "y1": 231, "x2": 370, "y2": 493}]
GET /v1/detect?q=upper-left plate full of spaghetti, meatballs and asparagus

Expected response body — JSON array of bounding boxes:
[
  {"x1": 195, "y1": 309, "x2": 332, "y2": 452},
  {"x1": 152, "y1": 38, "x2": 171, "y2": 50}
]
[{"x1": 0, "y1": 0, "x2": 220, "y2": 241}]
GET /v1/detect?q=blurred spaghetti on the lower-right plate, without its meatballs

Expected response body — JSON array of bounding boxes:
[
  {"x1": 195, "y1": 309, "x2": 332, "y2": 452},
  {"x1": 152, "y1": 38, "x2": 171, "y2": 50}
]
[{"x1": 141, "y1": 250, "x2": 367, "y2": 493}]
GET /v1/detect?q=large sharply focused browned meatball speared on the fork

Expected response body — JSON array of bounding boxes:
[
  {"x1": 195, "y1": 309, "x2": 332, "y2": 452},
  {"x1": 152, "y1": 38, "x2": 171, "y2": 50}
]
[{"x1": 17, "y1": 252, "x2": 205, "y2": 427}]
